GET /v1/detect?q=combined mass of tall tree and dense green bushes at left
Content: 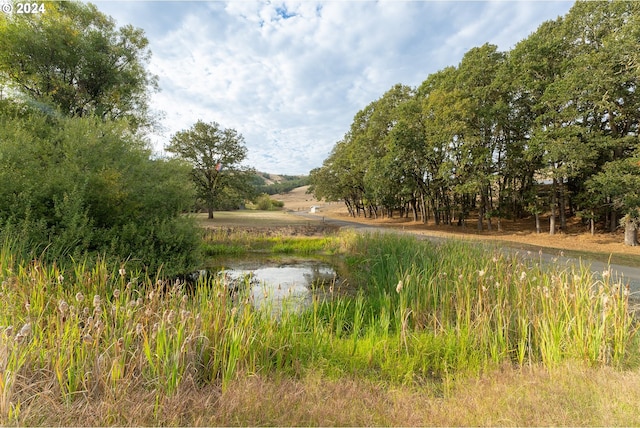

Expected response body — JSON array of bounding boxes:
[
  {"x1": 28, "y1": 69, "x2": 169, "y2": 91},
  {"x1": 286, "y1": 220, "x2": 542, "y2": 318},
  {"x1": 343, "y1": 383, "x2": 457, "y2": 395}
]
[{"x1": 0, "y1": 2, "x2": 199, "y2": 274}]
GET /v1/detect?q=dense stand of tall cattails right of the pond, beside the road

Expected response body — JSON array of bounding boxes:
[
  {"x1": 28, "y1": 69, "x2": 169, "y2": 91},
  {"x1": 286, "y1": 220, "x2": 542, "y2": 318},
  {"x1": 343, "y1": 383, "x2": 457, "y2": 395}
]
[{"x1": 340, "y1": 235, "x2": 638, "y2": 375}]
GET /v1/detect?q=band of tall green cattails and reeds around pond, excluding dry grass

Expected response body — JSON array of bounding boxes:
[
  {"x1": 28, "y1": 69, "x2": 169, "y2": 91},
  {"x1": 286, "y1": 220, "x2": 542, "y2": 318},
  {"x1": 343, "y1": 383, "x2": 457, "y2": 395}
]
[{"x1": 0, "y1": 234, "x2": 638, "y2": 425}]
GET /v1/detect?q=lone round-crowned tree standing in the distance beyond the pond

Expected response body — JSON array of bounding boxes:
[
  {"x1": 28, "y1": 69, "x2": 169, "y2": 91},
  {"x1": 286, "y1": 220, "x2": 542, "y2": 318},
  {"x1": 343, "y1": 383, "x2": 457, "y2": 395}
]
[{"x1": 166, "y1": 120, "x2": 254, "y2": 219}]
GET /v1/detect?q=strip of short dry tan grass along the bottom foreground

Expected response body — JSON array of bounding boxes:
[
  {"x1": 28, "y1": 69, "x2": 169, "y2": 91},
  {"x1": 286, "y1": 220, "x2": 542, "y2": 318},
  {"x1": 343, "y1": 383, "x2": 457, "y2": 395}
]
[{"x1": 12, "y1": 365, "x2": 640, "y2": 426}]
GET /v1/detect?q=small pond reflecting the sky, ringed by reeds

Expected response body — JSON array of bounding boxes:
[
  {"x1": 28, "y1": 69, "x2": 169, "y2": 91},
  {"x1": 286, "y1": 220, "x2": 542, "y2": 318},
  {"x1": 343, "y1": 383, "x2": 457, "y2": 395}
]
[{"x1": 210, "y1": 257, "x2": 348, "y2": 316}]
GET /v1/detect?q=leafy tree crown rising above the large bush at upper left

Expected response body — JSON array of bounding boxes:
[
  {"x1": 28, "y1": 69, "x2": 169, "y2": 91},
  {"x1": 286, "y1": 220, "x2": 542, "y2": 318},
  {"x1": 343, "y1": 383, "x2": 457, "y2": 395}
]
[{"x1": 0, "y1": 1, "x2": 157, "y2": 129}]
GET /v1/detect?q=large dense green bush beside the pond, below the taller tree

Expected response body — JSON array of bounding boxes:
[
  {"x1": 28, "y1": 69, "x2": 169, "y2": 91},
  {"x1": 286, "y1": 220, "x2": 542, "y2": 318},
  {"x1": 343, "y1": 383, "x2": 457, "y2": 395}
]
[{"x1": 0, "y1": 105, "x2": 198, "y2": 272}]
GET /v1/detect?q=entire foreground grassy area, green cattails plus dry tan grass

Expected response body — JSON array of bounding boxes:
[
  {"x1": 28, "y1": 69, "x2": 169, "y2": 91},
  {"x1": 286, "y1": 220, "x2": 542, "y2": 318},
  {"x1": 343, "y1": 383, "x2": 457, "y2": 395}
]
[{"x1": 0, "y1": 231, "x2": 640, "y2": 426}]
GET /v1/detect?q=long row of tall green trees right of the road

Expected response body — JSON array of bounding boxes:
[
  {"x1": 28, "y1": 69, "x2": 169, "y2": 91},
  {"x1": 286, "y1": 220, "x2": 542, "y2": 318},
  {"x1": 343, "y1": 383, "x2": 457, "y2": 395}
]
[{"x1": 310, "y1": 1, "x2": 640, "y2": 245}]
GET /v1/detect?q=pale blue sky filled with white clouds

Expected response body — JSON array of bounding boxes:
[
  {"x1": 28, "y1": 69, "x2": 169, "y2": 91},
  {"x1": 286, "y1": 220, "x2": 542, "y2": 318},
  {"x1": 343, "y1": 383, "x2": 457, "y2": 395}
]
[{"x1": 93, "y1": 0, "x2": 573, "y2": 175}]
